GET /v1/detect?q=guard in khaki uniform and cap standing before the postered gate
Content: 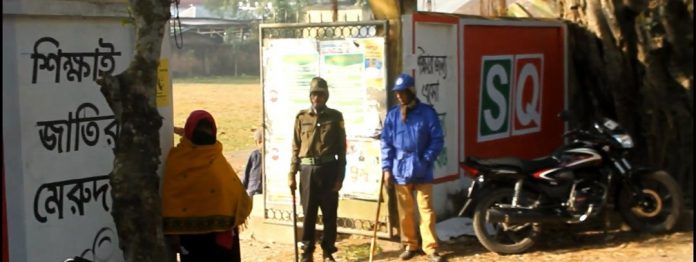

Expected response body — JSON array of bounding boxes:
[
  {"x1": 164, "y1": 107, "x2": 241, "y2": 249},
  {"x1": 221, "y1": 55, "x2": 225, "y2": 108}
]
[{"x1": 288, "y1": 77, "x2": 346, "y2": 261}]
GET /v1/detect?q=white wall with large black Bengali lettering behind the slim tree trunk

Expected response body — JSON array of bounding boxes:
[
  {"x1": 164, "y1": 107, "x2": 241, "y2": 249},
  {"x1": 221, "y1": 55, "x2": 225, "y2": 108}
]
[{"x1": 2, "y1": 1, "x2": 173, "y2": 261}]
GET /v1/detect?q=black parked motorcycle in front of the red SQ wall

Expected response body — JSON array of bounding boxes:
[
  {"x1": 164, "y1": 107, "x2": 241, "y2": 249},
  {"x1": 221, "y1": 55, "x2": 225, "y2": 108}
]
[{"x1": 459, "y1": 112, "x2": 682, "y2": 254}]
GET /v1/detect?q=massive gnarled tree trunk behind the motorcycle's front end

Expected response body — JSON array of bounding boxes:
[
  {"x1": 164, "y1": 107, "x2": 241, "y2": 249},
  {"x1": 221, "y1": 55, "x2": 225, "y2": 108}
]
[{"x1": 557, "y1": 0, "x2": 694, "y2": 204}]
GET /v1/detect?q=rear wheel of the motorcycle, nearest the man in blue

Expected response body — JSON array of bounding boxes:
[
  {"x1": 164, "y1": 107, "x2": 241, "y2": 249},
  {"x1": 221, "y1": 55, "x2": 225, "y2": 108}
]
[{"x1": 473, "y1": 188, "x2": 539, "y2": 255}]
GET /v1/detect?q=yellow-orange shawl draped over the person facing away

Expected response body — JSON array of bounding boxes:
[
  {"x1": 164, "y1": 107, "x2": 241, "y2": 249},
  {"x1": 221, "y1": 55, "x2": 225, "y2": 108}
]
[{"x1": 162, "y1": 137, "x2": 252, "y2": 235}]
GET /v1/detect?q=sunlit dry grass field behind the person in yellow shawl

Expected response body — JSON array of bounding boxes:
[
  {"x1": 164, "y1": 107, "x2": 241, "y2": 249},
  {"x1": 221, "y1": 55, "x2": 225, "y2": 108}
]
[{"x1": 173, "y1": 77, "x2": 262, "y2": 154}]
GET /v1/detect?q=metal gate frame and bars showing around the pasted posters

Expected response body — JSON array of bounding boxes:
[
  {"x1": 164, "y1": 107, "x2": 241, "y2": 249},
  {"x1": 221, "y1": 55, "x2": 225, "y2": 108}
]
[{"x1": 259, "y1": 21, "x2": 396, "y2": 237}]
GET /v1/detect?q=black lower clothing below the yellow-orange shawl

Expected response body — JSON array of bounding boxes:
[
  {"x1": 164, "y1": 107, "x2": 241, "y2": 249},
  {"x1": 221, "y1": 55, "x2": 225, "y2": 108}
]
[{"x1": 180, "y1": 229, "x2": 242, "y2": 262}]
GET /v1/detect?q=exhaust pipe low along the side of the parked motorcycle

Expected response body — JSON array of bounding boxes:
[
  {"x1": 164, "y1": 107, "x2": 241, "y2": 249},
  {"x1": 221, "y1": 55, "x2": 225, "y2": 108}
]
[{"x1": 486, "y1": 207, "x2": 565, "y2": 224}]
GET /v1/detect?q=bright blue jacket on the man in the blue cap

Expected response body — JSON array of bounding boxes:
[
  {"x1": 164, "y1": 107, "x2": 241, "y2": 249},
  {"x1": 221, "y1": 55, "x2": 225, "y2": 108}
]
[{"x1": 381, "y1": 101, "x2": 444, "y2": 185}]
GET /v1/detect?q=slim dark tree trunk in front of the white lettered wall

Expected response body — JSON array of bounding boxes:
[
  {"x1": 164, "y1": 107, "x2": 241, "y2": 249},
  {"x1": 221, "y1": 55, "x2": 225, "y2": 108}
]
[{"x1": 98, "y1": 0, "x2": 170, "y2": 261}]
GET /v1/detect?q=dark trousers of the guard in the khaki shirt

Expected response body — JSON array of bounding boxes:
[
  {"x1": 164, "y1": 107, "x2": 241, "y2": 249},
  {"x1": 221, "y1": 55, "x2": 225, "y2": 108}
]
[{"x1": 300, "y1": 161, "x2": 338, "y2": 254}]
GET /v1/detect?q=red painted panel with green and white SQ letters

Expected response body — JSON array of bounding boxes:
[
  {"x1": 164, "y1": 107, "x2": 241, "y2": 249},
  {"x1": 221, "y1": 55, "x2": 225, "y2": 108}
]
[{"x1": 460, "y1": 20, "x2": 566, "y2": 158}]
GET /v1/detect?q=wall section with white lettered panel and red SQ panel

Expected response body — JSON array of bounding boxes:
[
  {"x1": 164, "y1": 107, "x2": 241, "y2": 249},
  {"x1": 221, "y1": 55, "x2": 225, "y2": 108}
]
[{"x1": 402, "y1": 13, "x2": 567, "y2": 218}]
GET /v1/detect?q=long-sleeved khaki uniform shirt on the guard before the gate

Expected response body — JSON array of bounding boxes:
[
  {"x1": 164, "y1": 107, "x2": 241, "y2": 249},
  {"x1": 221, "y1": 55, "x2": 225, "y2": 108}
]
[{"x1": 290, "y1": 107, "x2": 346, "y2": 181}]
